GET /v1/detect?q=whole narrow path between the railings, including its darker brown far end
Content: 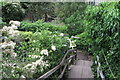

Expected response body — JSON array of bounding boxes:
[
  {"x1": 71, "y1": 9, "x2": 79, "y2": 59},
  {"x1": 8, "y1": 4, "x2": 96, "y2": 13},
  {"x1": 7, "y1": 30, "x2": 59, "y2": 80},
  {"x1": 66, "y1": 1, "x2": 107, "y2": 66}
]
[{"x1": 68, "y1": 52, "x2": 93, "y2": 78}]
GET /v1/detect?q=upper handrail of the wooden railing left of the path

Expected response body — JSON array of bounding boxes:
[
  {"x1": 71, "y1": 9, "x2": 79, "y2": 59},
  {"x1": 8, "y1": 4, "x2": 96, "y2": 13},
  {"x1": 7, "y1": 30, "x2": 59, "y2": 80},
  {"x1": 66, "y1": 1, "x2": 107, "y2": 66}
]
[{"x1": 36, "y1": 49, "x2": 77, "y2": 80}]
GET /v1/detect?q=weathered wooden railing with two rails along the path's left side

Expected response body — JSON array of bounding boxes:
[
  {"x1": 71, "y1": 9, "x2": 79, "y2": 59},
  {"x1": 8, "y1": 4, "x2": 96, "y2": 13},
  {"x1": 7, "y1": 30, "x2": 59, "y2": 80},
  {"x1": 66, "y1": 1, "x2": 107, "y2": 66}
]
[{"x1": 36, "y1": 49, "x2": 77, "y2": 80}]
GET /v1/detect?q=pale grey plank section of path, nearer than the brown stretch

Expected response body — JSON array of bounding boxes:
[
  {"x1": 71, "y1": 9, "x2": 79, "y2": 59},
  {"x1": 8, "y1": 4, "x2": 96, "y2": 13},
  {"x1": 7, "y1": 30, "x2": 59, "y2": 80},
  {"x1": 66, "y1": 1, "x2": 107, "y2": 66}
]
[{"x1": 68, "y1": 60, "x2": 93, "y2": 79}]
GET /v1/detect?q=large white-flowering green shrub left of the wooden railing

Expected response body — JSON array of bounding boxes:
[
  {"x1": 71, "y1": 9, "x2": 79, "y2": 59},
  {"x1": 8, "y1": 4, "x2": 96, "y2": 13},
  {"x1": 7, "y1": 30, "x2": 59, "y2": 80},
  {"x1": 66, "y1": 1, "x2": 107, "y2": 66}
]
[{"x1": 0, "y1": 21, "x2": 75, "y2": 78}]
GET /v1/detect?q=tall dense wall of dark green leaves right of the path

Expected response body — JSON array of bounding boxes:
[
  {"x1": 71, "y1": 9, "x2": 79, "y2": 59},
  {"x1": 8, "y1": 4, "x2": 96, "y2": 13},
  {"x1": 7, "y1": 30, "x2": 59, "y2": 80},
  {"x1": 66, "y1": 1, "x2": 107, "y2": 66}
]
[{"x1": 85, "y1": 2, "x2": 120, "y2": 78}]
